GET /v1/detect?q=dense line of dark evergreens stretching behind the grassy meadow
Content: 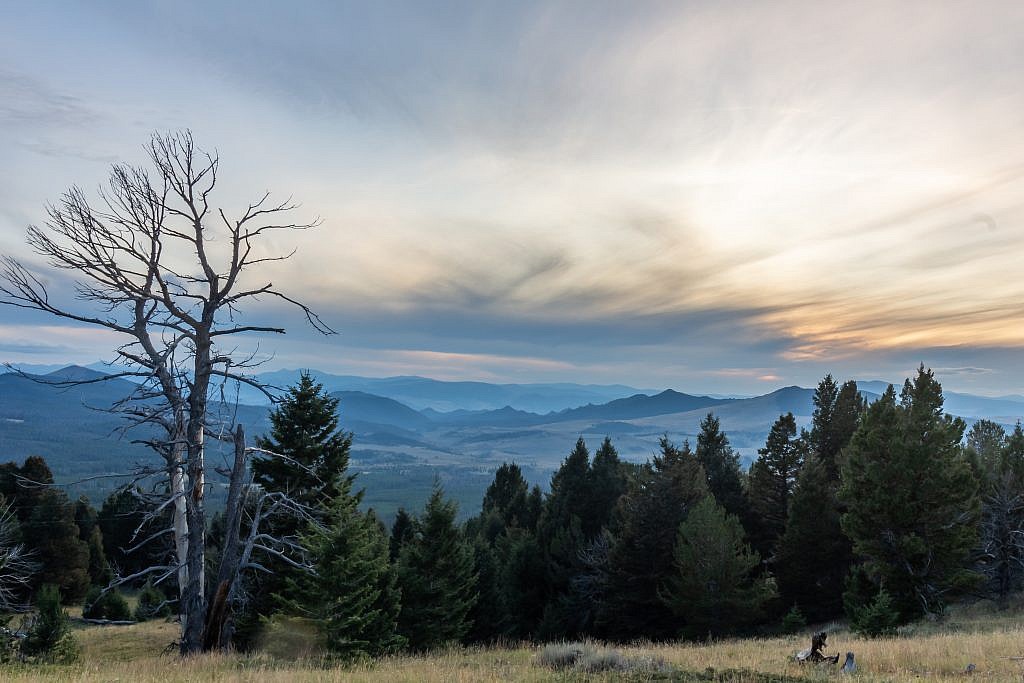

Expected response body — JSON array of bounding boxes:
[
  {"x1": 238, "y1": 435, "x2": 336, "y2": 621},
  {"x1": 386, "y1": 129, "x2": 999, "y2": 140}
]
[{"x1": 0, "y1": 367, "x2": 1024, "y2": 657}]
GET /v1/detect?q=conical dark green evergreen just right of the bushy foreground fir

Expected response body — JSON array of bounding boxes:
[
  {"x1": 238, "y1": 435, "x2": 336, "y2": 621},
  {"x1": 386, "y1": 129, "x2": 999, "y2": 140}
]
[{"x1": 398, "y1": 484, "x2": 477, "y2": 651}]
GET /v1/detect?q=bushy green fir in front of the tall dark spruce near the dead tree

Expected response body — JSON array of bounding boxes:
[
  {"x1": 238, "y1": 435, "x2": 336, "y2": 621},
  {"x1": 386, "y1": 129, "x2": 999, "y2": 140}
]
[{"x1": 288, "y1": 496, "x2": 406, "y2": 659}]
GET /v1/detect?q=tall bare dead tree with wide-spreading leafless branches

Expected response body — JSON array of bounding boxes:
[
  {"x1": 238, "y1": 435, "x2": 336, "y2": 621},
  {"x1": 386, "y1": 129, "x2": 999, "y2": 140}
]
[{"x1": 0, "y1": 131, "x2": 333, "y2": 653}]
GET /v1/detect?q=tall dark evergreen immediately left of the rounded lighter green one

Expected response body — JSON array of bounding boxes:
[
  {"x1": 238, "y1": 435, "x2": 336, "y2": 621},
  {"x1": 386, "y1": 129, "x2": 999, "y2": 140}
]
[{"x1": 597, "y1": 437, "x2": 708, "y2": 641}]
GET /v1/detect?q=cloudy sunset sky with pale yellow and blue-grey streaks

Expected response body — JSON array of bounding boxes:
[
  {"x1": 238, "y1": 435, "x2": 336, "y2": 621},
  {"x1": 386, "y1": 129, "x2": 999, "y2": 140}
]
[{"x1": 0, "y1": 0, "x2": 1024, "y2": 395}]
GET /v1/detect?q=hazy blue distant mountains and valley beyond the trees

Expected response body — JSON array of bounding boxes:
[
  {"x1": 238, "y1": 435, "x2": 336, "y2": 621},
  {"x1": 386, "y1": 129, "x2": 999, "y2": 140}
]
[{"x1": 0, "y1": 366, "x2": 1024, "y2": 516}]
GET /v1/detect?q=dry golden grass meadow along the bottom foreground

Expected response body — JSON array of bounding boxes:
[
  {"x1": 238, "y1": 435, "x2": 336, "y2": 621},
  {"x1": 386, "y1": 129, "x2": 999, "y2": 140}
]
[{"x1": 6, "y1": 604, "x2": 1024, "y2": 683}]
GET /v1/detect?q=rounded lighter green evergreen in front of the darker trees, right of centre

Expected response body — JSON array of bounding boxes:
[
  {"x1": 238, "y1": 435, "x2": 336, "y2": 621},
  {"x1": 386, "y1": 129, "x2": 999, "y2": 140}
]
[{"x1": 662, "y1": 496, "x2": 773, "y2": 638}]
